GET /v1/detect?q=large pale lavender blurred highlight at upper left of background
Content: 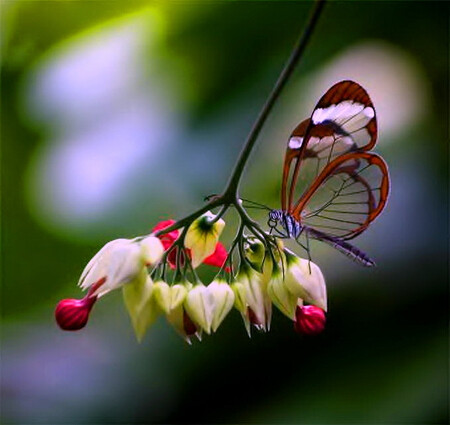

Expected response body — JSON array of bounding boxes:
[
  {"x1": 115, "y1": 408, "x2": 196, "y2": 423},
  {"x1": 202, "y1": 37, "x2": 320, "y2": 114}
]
[{"x1": 23, "y1": 13, "x2": 175, "y2": 228}]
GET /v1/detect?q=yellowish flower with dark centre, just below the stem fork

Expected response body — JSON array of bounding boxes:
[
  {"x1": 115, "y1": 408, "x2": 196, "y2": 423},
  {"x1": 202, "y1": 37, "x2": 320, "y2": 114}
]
[{"x1": 184, "y1": 212, "x2": 225, "y2": 268}]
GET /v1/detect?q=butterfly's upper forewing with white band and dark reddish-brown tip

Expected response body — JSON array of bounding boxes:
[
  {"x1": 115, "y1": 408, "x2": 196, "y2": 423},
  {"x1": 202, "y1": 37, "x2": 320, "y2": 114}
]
[{"x1": 281, "y1": 81, "x2": 377, "y2": 213}]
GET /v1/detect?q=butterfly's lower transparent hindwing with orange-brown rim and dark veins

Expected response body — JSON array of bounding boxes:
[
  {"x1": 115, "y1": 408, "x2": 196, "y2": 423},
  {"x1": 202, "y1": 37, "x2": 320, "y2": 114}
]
[{"x1": 292, "y1": 152, "x2": 389, "y2": 239}]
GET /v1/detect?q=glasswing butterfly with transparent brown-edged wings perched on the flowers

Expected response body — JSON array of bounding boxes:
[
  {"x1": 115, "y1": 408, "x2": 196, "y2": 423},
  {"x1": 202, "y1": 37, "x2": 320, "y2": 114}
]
[{"x1": 268, "y1": 80, "x2": 389, "y2": 267}]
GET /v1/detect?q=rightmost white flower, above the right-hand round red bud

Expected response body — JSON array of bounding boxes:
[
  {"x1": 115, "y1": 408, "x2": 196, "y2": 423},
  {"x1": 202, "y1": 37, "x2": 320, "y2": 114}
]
[{"x1": 285, "y1": 252, "x2": 327, "y2": 311}]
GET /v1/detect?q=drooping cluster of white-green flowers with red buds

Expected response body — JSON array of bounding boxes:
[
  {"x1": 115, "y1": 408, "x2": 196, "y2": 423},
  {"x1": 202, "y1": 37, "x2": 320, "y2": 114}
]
[{"x1": 55, "y1": 212, "x2": 327, "y2": 343}]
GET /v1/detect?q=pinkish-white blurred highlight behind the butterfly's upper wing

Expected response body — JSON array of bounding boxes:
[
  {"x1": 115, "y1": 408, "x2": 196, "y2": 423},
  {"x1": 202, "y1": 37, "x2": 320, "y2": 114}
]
[{"x1": 299, "y1": 41, "x2": 429, "y2": 139}]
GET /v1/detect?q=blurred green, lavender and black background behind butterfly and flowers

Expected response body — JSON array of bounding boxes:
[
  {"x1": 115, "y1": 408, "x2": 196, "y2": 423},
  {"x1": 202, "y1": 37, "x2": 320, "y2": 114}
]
[{"x1": 1, "y1": 0, "x2": 449, "y2": 424}]
